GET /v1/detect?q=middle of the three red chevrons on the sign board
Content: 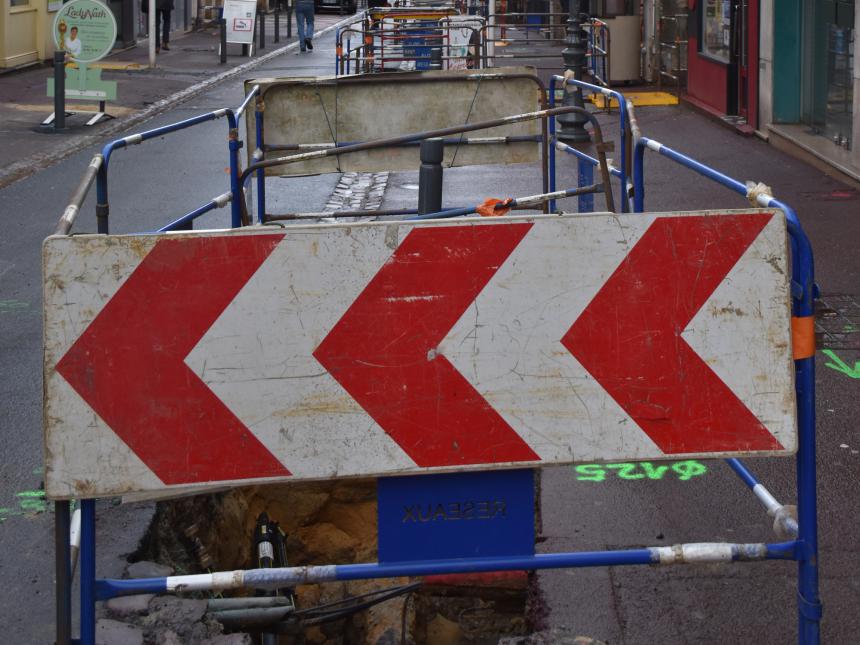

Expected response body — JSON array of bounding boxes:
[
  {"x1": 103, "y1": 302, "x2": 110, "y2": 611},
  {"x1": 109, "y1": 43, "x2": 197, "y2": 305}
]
[{"x1": 314, "y1": 224, "x2": 539, "y2": 466}]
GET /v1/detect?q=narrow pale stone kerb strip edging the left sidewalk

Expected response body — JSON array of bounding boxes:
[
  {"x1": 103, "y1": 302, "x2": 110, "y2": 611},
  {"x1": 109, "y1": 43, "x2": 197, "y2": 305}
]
[{"x1": 0, "y1": 16, "x2": 355, "y2": 189}]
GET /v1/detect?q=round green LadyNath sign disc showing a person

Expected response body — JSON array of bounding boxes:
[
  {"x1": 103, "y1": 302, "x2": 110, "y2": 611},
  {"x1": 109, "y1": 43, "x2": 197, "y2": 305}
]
[{"x1": 53, "y1": 0, "x2": 116, "y2": 63}]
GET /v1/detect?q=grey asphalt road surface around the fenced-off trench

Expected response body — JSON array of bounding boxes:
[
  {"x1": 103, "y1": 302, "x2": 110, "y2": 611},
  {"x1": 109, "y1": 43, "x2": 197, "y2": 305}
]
[{"x1": 0, "y1": 22, "x2": 860, "y2": 644}]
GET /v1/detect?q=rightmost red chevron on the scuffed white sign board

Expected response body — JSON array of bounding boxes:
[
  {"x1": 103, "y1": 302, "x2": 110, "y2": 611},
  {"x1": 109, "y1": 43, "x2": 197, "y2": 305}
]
[{"x1": 562, "y1": 213, "x2": 782, "y2": 454}]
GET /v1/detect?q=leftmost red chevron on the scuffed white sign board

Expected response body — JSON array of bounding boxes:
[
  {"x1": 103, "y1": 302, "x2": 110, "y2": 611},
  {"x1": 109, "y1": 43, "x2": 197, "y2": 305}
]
[{"x1": 57, "y1": 235, "x2": 290, "y2": 484}]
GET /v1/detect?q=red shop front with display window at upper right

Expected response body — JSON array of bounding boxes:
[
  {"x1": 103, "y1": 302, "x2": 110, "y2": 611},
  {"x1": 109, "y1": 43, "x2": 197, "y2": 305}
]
[{"x1": 686, "y1": 0, "x2": 759, "y2": 133}]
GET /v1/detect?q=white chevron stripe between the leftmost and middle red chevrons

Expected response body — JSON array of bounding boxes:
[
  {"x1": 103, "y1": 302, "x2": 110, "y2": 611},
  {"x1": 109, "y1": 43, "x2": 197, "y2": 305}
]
[{"x1": 185, "y1": 226, "x2": 414, "y2": 478}]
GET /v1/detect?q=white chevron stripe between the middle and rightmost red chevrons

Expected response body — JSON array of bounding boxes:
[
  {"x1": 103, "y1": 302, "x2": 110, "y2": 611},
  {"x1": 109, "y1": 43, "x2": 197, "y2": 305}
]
[{"x1": 441, "y1": 215, "x2": 662, "y2": 462}]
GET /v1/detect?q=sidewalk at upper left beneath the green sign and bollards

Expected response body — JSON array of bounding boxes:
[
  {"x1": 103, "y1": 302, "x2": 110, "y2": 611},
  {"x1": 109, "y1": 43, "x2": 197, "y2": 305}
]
[{"x1": 0, "y1": 13, "x2": 352, "y2": 188}]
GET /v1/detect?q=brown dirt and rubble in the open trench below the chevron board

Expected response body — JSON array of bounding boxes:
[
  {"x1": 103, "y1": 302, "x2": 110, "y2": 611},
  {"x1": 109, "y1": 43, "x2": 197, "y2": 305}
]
[{"x1": 122, "y1": 480, "x2": 542, "y2": 645}]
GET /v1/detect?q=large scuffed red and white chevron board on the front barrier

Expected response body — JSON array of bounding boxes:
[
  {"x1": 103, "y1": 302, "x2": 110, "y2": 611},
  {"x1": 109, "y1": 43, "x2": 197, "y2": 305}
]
[{"x1": 44, "y1": 211, "x2": 796, "y2": 498}]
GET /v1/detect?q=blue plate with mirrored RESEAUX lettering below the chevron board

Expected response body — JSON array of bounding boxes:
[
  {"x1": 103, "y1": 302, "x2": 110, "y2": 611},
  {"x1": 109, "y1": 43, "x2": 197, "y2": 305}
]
[{"x1": 378, "y1": 469, "x2": 535, "y2": 562}]
